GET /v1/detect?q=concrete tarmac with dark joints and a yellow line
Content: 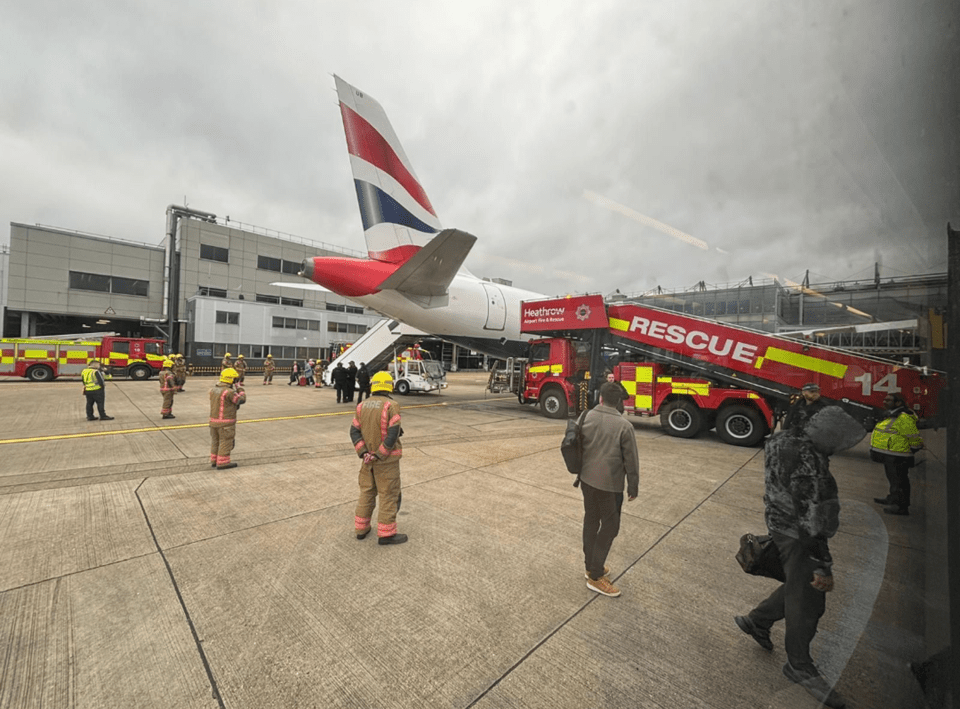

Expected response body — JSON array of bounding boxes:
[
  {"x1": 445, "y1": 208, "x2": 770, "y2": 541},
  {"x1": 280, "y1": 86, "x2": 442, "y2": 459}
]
[{"x1": 0, "y1": 372, "x2": 944, "y2": 709}]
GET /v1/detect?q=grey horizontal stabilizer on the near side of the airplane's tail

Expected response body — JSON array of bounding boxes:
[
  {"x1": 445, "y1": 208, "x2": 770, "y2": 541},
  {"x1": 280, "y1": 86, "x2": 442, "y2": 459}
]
[{"x1": 378, "y1": 229, "x2": 477, "y2": 299}]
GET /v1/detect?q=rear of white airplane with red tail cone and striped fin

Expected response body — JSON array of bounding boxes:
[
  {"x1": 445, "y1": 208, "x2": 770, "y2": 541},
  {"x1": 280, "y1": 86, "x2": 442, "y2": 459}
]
[{"x1": 300, "y1": 76, "x2": 543, "y2": 357}]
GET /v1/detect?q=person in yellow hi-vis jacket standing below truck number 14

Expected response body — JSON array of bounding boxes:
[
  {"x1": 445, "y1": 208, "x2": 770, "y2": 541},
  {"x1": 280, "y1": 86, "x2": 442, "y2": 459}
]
[{"x1": 870, "y1": 394, "x2": 923, "y2": 515}]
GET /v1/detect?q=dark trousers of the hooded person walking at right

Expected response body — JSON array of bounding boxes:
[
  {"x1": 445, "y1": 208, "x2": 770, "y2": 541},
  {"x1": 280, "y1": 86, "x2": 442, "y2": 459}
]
[{"x1": 749, "y1": 531, "x2": 827, "y2": 670}]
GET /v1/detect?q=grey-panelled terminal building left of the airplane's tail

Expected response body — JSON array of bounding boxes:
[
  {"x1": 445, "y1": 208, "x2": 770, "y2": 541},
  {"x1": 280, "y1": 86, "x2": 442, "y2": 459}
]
[{"x1": 3, "y1": 207, "x2": 381, "y2": 366}]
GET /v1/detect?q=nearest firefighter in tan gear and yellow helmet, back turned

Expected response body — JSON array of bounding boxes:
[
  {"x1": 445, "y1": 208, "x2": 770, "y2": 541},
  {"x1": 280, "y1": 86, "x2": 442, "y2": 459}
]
[{"x1": 350, "y1": 372, "x2": 407, "y2": 545}]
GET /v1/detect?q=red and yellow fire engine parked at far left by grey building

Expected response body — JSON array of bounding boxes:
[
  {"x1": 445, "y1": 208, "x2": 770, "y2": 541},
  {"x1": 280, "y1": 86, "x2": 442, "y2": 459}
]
[{"x1": 0, "y1": 335, "x2": 165, "y2": 382}]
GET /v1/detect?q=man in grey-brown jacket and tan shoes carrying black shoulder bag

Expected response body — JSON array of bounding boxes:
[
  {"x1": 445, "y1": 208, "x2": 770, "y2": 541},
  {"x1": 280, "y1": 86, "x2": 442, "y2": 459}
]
[{"x1": 579, "y1": 382, "x2": 640, "y2": 597}]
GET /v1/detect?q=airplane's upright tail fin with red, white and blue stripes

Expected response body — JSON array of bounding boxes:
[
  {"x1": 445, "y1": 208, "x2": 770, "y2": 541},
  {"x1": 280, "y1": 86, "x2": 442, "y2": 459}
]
[{"x1": 334, "y1": 76, "x2": 443, "y2": 263}]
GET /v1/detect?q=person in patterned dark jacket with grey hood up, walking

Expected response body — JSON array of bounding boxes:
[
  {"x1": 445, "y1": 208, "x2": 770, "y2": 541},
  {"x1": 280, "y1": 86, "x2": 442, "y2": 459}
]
[{"x1": 734, "y1": 406, "x2": 865, "y2": 707}]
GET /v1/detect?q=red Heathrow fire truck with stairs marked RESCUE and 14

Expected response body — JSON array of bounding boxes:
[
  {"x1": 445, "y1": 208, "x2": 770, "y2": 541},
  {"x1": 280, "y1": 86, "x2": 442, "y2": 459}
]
[{"x1": 491, "y1": 295, "x2": 945, "y2": 446}]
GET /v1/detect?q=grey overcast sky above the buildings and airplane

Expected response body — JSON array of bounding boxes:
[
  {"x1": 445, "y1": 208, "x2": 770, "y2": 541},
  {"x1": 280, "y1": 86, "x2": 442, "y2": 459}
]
[{"x1": 0, "y1": 0, "x2": 960, "y2": 294}]
